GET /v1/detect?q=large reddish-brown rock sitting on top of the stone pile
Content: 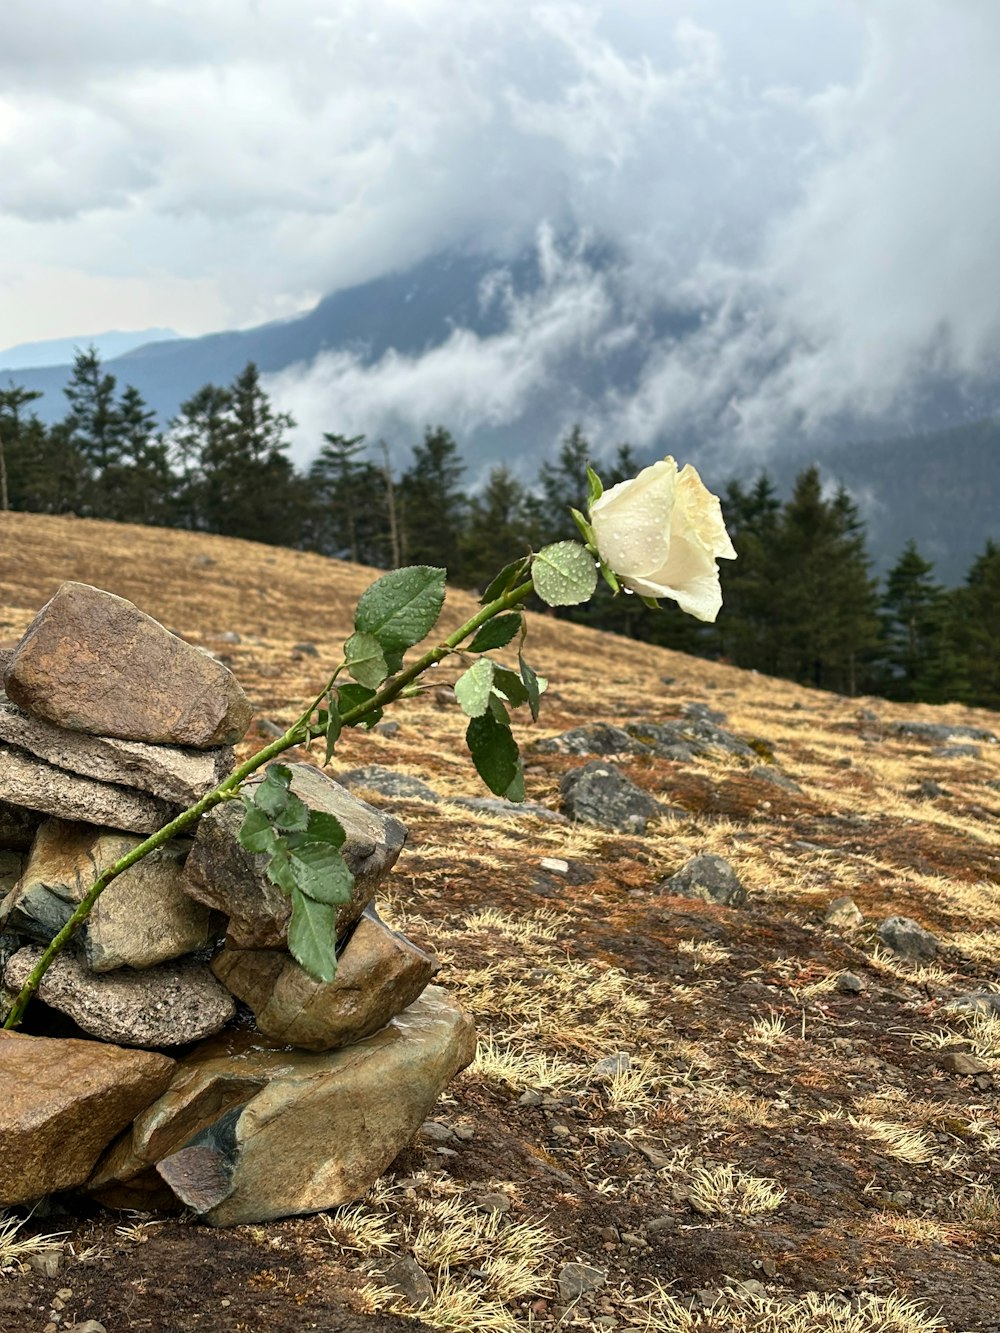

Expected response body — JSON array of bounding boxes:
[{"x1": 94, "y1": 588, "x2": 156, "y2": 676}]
[{"x1": 4, "y1": 583, "x2": 253, "y2": 749}]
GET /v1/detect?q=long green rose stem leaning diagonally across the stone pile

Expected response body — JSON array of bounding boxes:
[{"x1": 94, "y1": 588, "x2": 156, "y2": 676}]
[{"x1": 4, "y1": 583, "x2": 533, "y2": 1030}]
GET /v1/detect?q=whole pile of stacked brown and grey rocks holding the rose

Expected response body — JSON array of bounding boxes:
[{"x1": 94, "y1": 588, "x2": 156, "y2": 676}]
[{"x1": 0, "y1": 583, "x2": 475, "y2": 1225}]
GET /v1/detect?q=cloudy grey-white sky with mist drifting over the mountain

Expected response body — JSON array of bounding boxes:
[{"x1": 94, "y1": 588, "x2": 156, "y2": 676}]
[{"x1": 0, "y1": 0, "x2": 1000, "y2": 455}]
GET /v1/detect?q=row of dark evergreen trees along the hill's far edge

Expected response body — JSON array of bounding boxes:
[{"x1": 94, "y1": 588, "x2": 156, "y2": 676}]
[{"x1": 0, "y1": 348, "x2": 1000, "y2": 708}]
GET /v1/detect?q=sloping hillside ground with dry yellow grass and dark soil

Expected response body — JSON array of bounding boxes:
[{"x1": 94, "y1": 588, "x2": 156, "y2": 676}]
[{"x1": 0, "y1": 515, "x2": 1000, "y2": 1333}]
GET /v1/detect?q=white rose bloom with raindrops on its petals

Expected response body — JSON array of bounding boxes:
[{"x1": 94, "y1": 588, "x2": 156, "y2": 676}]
[{"x1": 589, "y1": 457, "x2": 736, "y2": 620}]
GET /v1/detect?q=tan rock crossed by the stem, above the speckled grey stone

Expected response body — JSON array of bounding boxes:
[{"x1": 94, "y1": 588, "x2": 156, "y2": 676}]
[{"x1": 0, "y1": 820, "x2": 216, "y2": 972}]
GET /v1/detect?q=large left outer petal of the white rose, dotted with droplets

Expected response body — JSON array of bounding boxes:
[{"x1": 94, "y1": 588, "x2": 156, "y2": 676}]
[{"x1": 591, "y1": 459, "x2": 677, "y2": 579}]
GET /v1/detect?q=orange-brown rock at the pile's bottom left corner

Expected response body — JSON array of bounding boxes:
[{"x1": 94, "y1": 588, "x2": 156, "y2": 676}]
[{"x1": 0, "y1": 1032, "x2": 175, "y2": 1205}]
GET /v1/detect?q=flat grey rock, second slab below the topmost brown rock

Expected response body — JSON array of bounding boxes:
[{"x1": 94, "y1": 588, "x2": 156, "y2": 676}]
[{"x1": 0, "y1": 744, "x2": 180, "y2": 833}]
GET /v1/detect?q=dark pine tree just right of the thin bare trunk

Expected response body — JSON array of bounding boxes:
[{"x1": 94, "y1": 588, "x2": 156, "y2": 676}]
[{"x1": 397, "y1": 425, "x2": 467, "y2": 583}]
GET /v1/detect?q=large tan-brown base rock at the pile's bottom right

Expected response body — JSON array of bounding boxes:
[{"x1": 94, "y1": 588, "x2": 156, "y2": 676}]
[{"x1": 93, "y1": 986, "x2": 476, "y2": 1226}]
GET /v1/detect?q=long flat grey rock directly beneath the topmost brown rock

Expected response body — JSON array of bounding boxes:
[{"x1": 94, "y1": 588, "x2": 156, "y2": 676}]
[{"x1": 0, "y1": 693, "x2": 233, "y2": 805}]
